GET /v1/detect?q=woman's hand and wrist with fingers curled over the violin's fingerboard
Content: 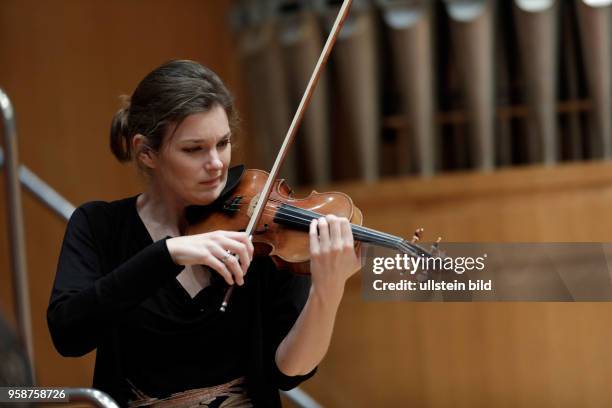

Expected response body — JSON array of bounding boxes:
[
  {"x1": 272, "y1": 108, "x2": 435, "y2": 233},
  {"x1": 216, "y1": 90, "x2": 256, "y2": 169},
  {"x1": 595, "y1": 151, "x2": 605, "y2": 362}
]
[{"x1": 310, "y1": 215, "x2": 361, "y2": 301}]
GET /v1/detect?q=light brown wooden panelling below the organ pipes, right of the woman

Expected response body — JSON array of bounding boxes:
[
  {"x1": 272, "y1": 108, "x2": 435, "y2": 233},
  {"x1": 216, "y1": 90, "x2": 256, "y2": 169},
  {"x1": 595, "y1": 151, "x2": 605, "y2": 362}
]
[{"x1": 298, "y1": 163, "x2": 612, "y2": 407}]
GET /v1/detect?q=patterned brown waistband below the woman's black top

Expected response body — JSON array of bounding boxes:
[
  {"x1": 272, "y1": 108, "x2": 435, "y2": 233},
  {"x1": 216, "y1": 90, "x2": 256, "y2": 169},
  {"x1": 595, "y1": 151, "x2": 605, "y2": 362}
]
[{"x1": 128, "y1": 377, "x2": 253, "y2": 408}]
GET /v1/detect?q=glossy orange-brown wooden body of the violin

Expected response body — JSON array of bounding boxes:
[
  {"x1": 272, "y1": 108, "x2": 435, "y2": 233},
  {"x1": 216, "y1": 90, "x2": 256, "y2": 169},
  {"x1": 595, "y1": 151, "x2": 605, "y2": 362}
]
[{"x1": 187, "y1": 169, "x2": 363, "y2": 274}]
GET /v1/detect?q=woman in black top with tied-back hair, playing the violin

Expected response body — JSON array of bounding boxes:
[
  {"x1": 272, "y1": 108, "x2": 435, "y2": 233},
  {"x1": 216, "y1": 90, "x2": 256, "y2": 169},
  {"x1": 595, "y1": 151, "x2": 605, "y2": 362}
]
[{"x1": 47, "y1": 61, "x2": 360, "y2": 407}]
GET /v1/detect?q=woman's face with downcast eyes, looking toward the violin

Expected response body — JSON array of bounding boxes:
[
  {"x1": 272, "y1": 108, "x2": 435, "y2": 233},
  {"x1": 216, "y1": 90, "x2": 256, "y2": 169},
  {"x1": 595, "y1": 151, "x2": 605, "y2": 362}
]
[{"x1": 148, "y1": 105, "x2": 232, "y2": 205}]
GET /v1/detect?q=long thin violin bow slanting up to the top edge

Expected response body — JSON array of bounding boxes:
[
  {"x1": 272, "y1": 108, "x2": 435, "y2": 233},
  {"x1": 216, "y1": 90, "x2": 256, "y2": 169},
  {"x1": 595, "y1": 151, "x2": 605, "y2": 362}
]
[{"x1": 219, "y1": 0, "x2": 353, "y2": 312}]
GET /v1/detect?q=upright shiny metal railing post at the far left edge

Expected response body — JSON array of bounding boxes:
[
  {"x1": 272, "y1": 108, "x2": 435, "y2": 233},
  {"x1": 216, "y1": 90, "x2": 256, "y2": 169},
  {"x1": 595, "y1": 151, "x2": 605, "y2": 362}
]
[{"x1": 0, "y1": 88, "x2": 36, "y2": 382}]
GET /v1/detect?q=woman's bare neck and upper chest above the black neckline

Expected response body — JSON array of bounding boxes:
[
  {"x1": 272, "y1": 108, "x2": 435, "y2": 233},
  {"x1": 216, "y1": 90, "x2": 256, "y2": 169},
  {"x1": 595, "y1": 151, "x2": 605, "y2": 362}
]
[{"x1": 136, "y1": 182, "x2": 187, "y2": 241}]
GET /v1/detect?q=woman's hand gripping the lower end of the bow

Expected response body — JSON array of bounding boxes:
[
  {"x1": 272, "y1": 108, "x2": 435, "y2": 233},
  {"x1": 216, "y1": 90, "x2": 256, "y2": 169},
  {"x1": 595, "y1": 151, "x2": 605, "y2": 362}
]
[{"x1": 166, "y1": 231, "x2": 253, "y2": 285}]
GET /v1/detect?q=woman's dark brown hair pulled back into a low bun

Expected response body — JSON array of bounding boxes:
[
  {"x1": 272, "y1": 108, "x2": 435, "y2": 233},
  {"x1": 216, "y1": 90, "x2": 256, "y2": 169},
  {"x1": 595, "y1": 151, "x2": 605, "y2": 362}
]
[{"x1": 110, "y1": 60, "x2": 238, "y2": 166}]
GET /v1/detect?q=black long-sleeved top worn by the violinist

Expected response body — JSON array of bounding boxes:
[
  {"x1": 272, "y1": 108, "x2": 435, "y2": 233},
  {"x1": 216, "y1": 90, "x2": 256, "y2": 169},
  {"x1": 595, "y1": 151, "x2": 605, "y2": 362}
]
[{"x1": 47, "y1": 168, "x2": 315, "y2": 407}]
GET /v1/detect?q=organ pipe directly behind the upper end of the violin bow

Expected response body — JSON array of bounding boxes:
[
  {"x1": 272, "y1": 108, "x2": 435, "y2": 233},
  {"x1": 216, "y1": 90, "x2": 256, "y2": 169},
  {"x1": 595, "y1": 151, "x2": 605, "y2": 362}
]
[{"x1": 315, "y1": 0, "x2": 381, "y2": 181}]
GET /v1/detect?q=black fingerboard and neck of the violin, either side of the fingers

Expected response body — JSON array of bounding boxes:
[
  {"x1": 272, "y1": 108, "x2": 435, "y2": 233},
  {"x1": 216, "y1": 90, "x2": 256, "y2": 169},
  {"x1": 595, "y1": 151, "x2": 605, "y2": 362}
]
[{"x1": 274, "y1": 204, "x2": 430, "y2": 256}]
